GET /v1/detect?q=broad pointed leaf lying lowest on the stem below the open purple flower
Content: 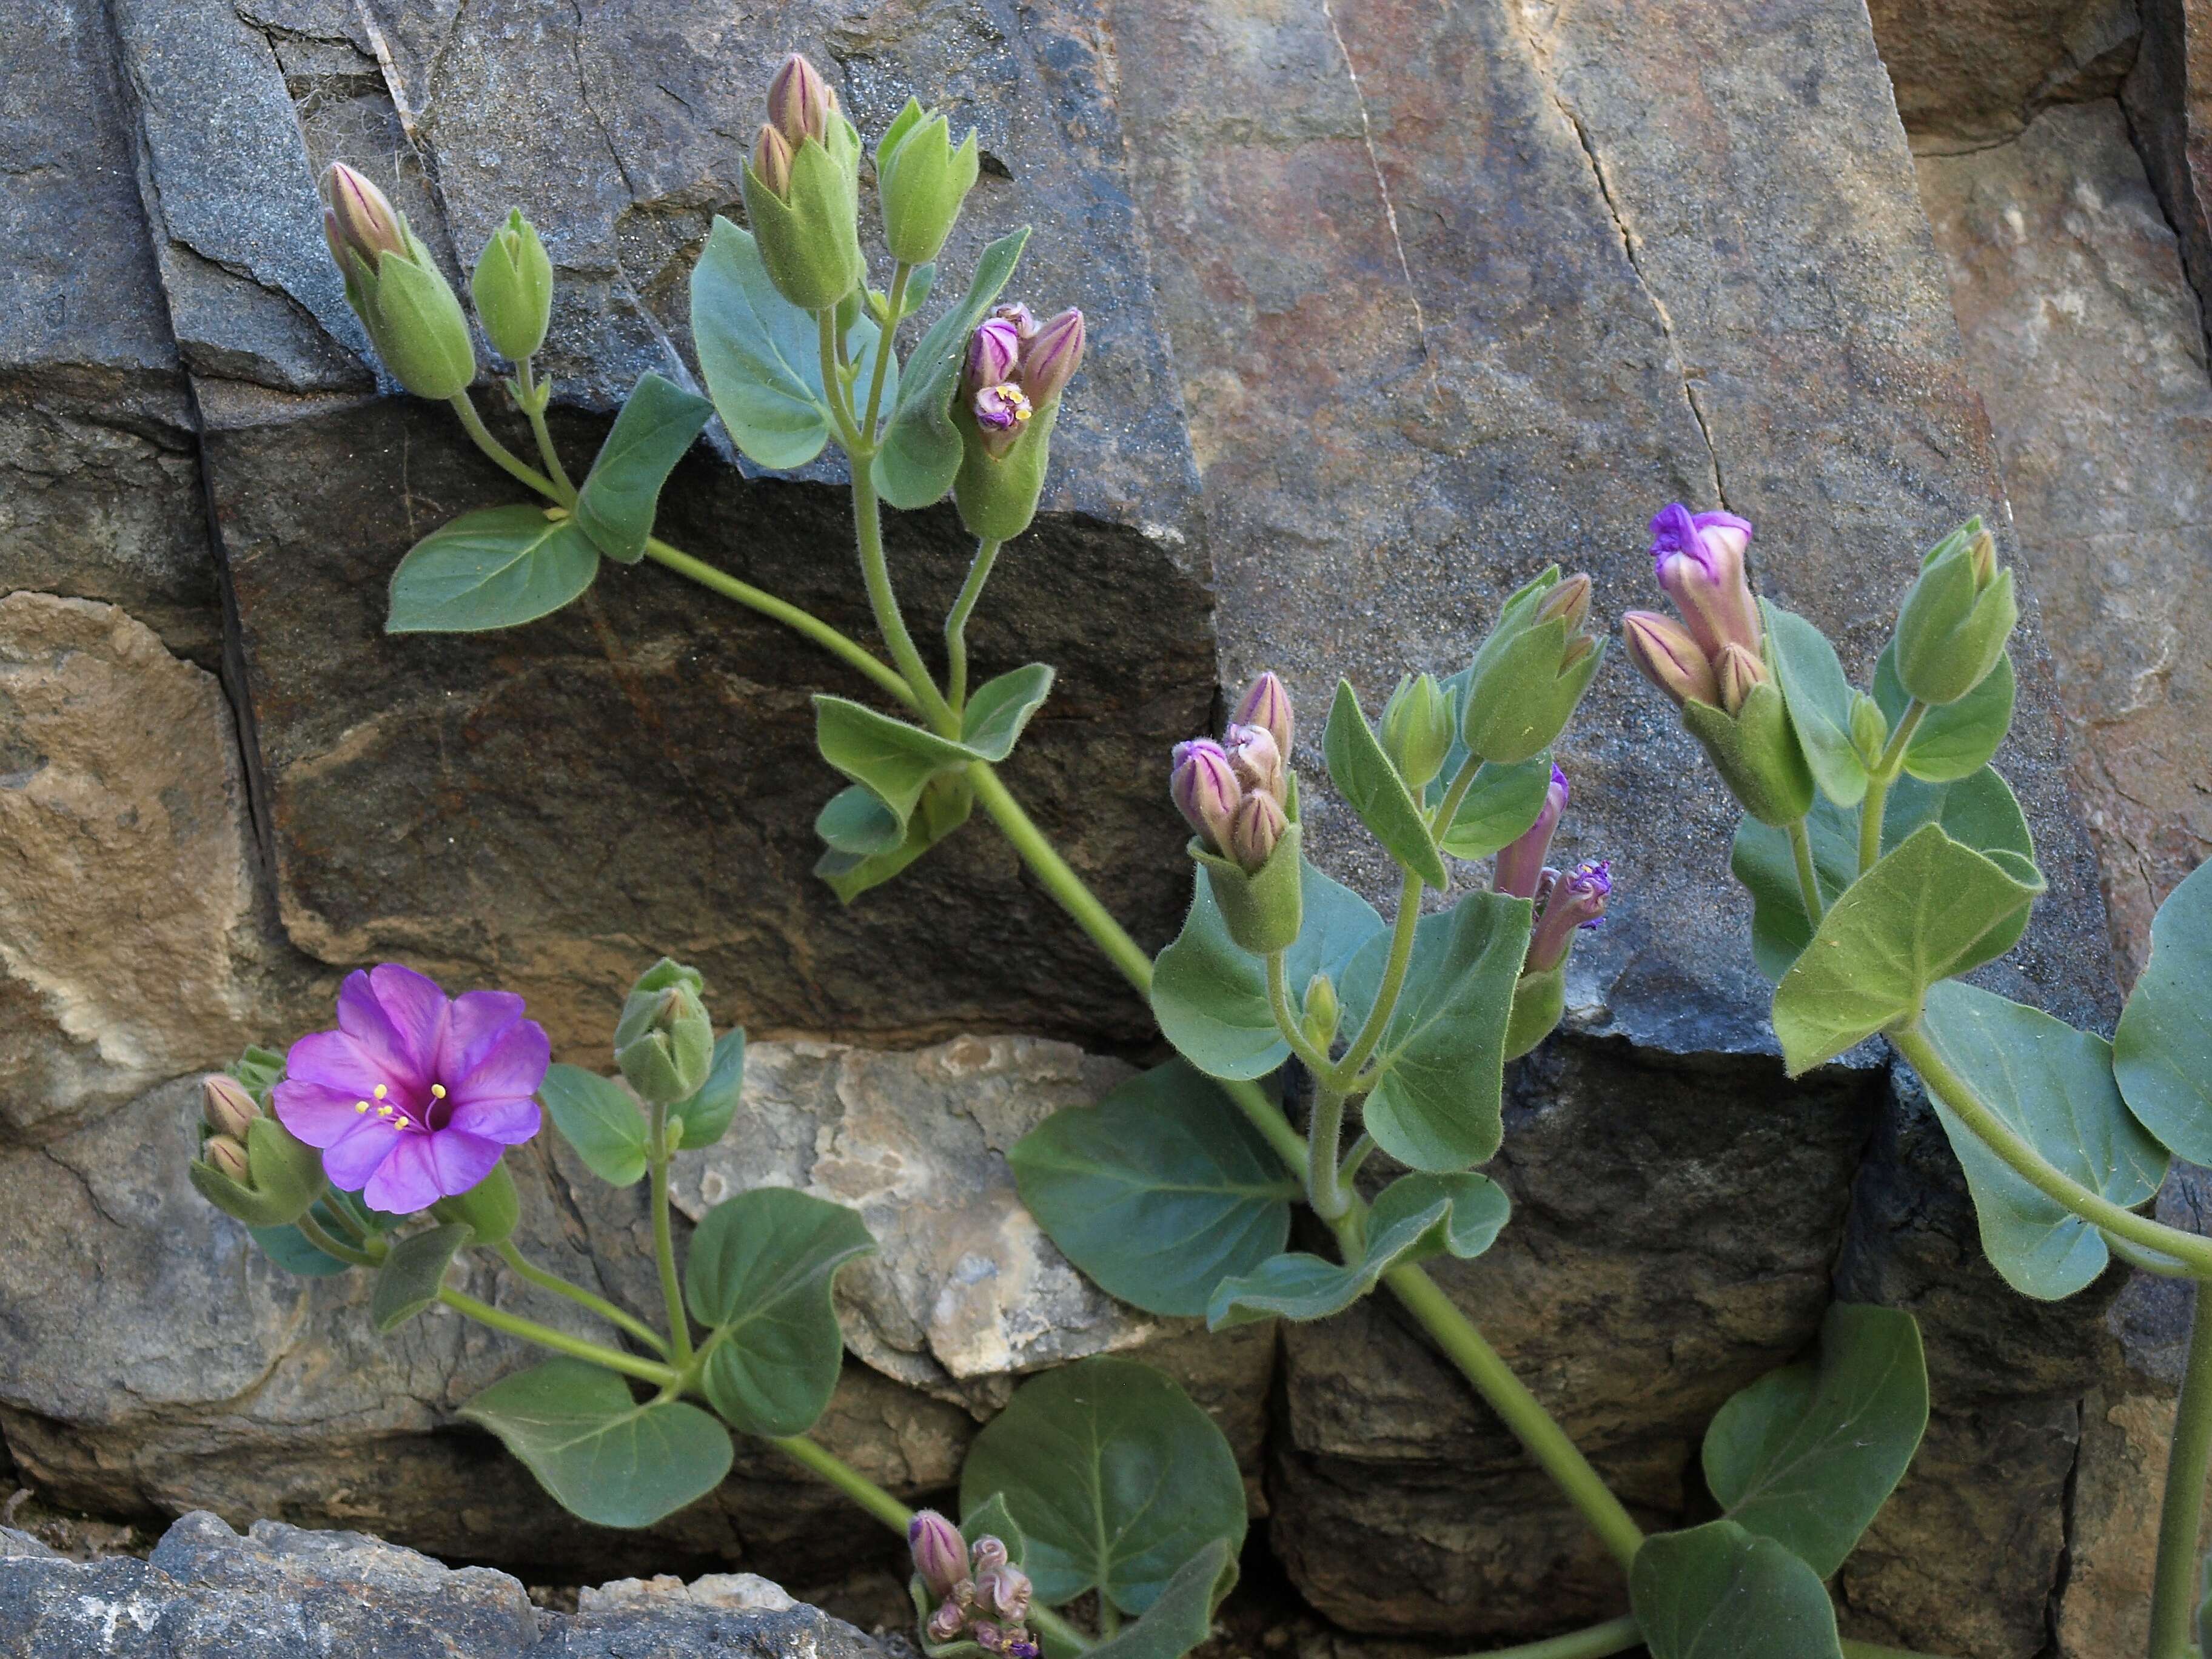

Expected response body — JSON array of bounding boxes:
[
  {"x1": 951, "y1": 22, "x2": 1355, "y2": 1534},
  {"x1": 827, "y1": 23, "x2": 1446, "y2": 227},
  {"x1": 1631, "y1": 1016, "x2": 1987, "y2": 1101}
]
[{"x1": 460, "y1": 1358, "x2": 730, "y2": 1526}]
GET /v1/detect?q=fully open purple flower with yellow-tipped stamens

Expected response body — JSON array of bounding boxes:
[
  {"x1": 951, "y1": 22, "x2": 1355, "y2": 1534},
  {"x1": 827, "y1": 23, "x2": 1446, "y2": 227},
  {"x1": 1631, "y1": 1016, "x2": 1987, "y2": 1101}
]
[{"x1": 274, "y1": 962, "x2": 553, "y2": 1215}]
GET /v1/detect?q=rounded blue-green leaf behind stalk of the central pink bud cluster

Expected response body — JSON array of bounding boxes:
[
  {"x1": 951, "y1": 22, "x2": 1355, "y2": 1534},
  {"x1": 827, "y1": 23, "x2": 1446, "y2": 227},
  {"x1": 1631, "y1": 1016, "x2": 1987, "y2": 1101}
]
[{"x1": 1153, "y1": 865, "x2": 1382, "y2": 1079}]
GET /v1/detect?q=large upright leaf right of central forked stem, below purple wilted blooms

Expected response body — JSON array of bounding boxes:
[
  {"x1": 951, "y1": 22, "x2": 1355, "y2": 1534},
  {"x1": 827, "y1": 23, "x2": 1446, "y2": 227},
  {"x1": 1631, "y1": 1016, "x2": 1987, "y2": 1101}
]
[{"x1": 1338, "y1": 891, "x2": 1530, "y2": 1175}]
